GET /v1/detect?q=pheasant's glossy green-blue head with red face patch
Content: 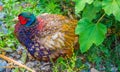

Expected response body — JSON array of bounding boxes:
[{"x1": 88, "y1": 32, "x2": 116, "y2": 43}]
[{"x1": 18, "y1": 12, "x2": 36, "y2": 27}]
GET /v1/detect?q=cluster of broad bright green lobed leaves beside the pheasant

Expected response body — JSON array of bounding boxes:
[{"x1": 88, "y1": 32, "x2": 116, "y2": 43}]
[{"x1": 75, "y1": 0, "x2": 120, "y2": 51}]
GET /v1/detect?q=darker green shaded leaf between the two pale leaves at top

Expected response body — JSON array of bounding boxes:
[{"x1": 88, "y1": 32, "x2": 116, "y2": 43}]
[{"x1": 82, "y1": 4, "x2": 101, "y2": 21}]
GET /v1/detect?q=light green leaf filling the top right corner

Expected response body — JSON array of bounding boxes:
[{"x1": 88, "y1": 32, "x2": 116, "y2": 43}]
[{"x1": 102, "y1": 0, "x2": 120, "y2": 21}]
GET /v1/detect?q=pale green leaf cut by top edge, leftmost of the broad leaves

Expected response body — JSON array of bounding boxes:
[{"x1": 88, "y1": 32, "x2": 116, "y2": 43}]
[{"x1": 75, "y1": 0, "x2": 93, "y2": 14}]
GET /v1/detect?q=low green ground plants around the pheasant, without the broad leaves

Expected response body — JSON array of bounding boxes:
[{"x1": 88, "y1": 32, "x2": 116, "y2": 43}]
[{"x1": 0, "y1": 0, "x2": 120, "y2": 72}]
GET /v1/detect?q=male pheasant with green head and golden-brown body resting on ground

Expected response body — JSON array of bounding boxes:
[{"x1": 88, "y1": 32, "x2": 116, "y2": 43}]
[{"x1": 14, "y1": 12, "x2": 77, "y2": 61}]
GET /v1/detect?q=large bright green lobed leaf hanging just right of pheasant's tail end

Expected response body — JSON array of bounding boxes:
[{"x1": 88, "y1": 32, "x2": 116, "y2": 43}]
[{"x1": 75, "y1": 19, "x2": 107, "y2": 53}]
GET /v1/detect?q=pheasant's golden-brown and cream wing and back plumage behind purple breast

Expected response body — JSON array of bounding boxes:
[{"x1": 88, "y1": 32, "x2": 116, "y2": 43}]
[{"x1": 35, "y1": 14, "x2": 77, "y2": 61}]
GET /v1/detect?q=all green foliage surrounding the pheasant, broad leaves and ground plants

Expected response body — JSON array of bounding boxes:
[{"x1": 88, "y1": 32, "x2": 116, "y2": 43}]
[{"x1": 0, "y1": 0, "x2": 120, "y2": 72}]
